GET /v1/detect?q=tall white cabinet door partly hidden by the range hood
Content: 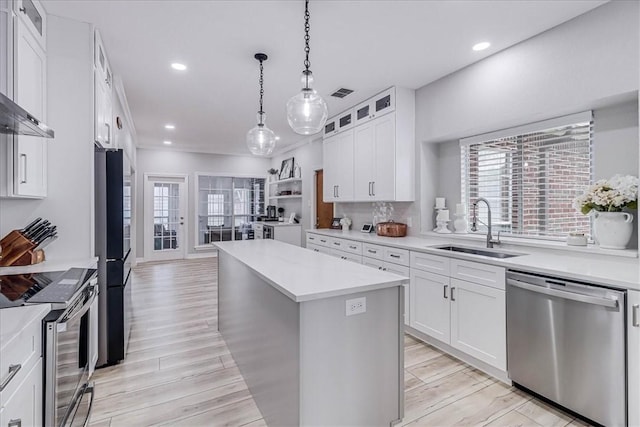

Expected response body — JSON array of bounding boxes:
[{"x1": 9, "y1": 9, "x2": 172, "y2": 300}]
[{"x1": 12, "y1": 14, "x2": 48, "y2": 198}]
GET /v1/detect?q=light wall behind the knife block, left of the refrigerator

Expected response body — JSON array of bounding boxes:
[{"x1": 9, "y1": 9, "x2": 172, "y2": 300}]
[{"x1": 0, "y1": 15, "x2": 94, "y2": 260}]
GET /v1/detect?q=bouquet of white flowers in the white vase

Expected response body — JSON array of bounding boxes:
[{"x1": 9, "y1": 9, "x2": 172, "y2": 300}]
[{"x1": 573, "y1": 175, "x2": 638, "y2": 215}]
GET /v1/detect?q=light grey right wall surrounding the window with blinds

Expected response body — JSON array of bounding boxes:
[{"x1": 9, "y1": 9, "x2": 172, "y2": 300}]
[{"x1": 416, "y1": 2, "x2": 640, "y2": 231}]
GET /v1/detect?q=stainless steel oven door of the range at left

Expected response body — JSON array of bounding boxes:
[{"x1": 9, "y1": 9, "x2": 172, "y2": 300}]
[{"x1": 45, "y1": 287, "x2": 97, "y2": 427}]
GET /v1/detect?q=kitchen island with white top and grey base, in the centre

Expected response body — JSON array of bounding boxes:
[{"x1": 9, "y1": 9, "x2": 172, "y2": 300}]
[{"x1": 215, "y1": 240, "x2": 408, "y2": 426}]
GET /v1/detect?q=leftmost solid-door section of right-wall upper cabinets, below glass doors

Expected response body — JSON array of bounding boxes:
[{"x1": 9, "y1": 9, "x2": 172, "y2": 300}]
[{"x1": 322, "y1": 130, "x2": 353, "y2": 202}]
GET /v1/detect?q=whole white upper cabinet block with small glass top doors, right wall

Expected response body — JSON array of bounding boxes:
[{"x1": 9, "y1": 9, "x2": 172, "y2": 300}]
[{"x1": 323, "y1": 87, "x2": 416, "y2": 202}]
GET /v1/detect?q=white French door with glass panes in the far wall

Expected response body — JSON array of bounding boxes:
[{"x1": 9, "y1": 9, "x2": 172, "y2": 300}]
[{"x1": 144, "y1": 175, "x2": 187, "y2": 261}]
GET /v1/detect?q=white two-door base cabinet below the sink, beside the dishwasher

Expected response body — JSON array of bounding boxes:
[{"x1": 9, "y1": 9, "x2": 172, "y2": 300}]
[{"x1": 410, "y1": 252, "x2": 507, "y2": 371}]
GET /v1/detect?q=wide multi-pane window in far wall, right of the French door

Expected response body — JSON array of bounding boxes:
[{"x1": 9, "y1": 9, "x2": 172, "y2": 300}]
[{"x1": 196, "y1": 175, "x2": 265, "y2": 245}]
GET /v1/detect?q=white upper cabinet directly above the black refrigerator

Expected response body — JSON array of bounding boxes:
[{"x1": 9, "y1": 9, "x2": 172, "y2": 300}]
[{"x1": 93, "y1": 30, "x2": 113, "y2": 147}]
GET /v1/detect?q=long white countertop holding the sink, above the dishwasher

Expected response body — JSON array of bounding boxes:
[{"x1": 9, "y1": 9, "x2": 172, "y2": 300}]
[{"x1": 307, "y1": 229, "x2": 640, "y2": 291}]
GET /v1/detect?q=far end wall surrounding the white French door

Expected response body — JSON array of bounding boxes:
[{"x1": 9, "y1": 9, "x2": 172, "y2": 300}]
[{"x1": 136, "y1": 148, "x2": 271, "y2": 258}]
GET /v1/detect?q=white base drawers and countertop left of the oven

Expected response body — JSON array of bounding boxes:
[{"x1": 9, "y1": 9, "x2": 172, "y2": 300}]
[{"x1": 0, "y1": 305, "x2": 49, "y2": 427}]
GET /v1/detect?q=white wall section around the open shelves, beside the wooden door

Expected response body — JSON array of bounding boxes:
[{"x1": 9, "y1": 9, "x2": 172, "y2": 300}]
[{"x1": 269, "y1": 137, "x2": 322, "y2": 244}]
